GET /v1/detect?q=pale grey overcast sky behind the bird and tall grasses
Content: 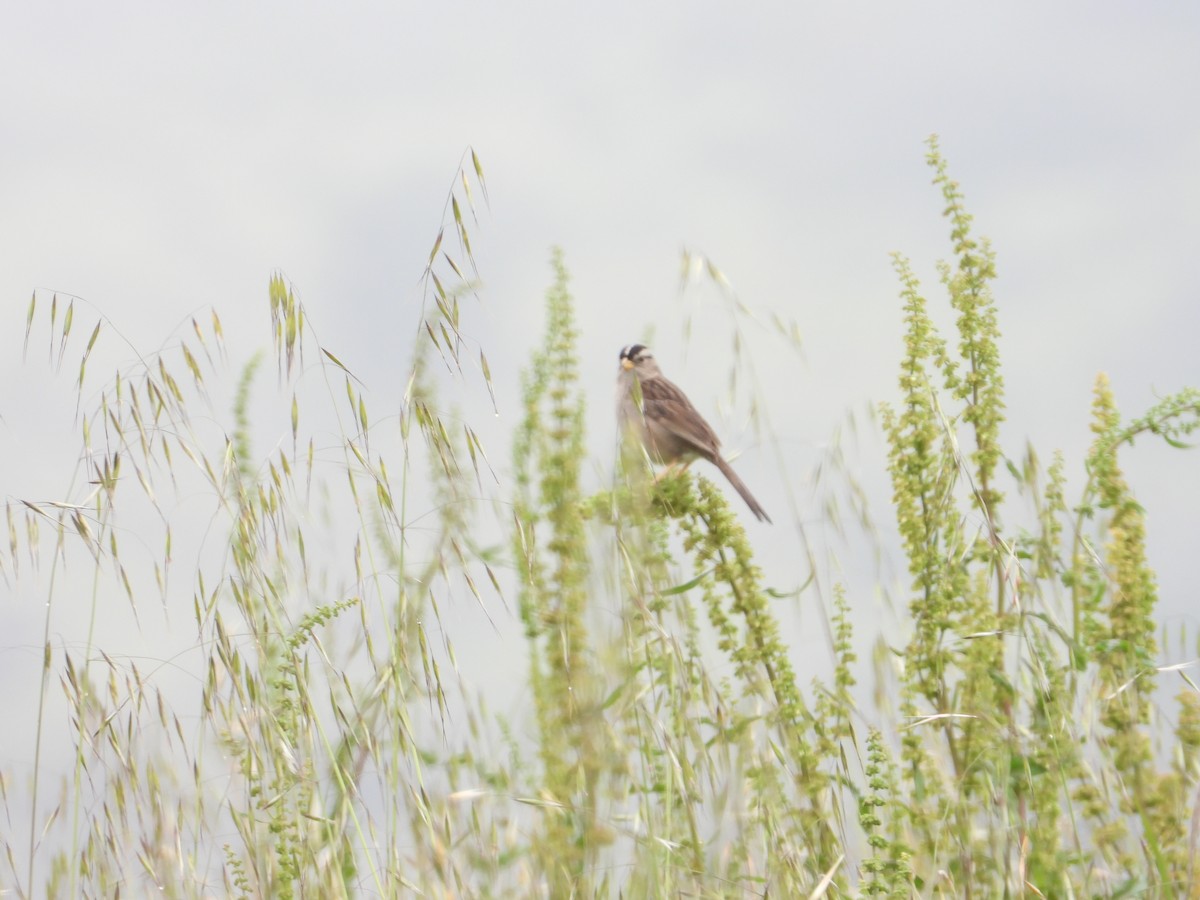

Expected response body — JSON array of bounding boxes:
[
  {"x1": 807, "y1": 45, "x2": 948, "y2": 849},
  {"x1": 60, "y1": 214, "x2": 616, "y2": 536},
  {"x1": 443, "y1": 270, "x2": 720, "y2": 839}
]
[{"x1": 7, "y1": 1, "x2": 1200, "y2": 796}]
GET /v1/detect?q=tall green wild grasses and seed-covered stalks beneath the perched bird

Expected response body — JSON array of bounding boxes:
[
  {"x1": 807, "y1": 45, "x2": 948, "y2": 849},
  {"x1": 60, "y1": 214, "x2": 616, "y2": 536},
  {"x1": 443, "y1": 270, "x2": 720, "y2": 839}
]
[{"x1": 0, "y1": 139, "x2": 1200, "y2": 898}]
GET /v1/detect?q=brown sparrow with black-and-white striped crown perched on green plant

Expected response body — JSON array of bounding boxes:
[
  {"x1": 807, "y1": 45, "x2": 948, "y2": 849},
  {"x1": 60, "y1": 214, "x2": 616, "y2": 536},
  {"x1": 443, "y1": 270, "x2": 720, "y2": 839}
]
[{"x1": 617, "y1": 343, "x2": 770, "y2": 522}]
